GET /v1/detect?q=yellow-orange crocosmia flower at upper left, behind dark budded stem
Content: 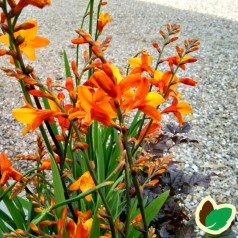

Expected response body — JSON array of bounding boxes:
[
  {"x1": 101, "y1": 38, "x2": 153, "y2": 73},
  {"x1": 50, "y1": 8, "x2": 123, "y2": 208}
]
[{"x1": 0, "y1": 20, "x2": 50, "y2": 61}]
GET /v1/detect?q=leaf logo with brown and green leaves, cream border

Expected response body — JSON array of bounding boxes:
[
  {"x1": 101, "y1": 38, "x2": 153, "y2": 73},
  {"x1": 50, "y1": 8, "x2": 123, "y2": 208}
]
[{"x1": 195, "y1": 196, "x2": 236, "y2": 235}]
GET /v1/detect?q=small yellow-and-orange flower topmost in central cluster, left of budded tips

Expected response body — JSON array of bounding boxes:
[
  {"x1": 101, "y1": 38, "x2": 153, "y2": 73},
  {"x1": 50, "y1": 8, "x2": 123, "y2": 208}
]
[{"x1": 128, "y1": 51, "x2": 154, "y2": 75}]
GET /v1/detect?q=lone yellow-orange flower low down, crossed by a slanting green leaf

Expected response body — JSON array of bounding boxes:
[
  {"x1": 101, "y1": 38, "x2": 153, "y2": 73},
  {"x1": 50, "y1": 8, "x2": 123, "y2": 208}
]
[{"x1": 69, "y1": 171, "x2": 95, "y2": 202}]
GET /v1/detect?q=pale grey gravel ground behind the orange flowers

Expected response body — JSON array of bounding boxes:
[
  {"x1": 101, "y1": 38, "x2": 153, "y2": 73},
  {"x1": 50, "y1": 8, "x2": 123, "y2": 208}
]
[{"x1": 0, "y1": 0, "x2": 238, "y2": 237}]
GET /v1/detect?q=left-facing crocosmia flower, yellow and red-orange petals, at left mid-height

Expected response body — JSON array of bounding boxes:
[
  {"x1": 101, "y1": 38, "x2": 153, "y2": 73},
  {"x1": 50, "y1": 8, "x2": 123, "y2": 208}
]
[{"x1": 12, "y1": 101, "x2": 58, "y2": 135}]
